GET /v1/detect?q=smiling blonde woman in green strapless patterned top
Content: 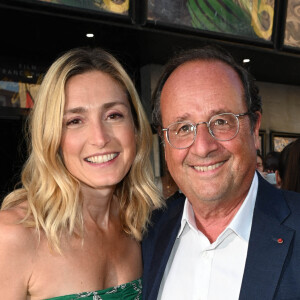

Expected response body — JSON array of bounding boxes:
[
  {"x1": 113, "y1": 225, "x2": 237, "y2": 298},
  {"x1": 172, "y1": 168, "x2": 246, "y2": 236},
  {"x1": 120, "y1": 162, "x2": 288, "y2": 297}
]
[{"x1": 0, "y1": 48, "x2": 161, "y2": 300}]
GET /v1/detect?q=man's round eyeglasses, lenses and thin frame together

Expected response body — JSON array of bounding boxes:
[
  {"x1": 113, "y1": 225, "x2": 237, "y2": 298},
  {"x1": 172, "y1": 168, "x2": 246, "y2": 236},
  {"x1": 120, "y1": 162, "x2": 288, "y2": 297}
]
[{"x1": 162, "y1": 112, "x2": 250, "y2": 149}]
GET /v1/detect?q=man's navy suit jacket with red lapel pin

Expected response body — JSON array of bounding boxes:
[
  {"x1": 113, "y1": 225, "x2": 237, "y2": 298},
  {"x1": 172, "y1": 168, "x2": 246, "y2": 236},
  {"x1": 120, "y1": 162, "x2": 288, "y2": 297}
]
[{"x1": 142, "y1": 175, "x2": 300, "y2": 300}]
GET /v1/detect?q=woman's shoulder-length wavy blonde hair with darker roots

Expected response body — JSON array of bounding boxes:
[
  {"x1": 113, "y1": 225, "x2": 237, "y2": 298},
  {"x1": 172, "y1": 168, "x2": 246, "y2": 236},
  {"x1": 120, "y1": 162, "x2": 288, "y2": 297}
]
[{"x1": 2, "y1": 48, "x2": 161, "y2": 252}]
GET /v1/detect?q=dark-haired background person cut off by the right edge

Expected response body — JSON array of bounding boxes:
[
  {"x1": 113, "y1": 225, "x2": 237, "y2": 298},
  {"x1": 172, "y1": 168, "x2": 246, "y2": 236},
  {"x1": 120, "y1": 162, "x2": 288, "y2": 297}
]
[{"x1": 275, "y1": 139, "x2": 300, "y2": 193}]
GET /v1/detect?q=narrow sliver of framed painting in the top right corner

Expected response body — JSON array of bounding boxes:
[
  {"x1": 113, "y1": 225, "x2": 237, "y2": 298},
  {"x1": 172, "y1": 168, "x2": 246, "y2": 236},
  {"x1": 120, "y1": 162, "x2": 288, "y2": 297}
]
[{"x1": 284, "y1": 0, "x2": 300, "y2": 47}]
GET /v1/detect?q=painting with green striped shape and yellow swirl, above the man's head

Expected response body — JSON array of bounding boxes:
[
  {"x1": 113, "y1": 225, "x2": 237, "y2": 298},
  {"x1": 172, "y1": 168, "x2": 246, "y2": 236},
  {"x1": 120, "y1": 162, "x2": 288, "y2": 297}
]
[{"x1": 148, "y1": 0, "x2": 274, "y2": 41}]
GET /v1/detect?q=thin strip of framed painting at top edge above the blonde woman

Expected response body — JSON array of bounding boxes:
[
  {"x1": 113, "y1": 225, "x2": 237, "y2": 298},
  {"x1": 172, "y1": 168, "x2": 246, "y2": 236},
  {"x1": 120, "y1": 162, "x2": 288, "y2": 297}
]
[{"x1": 37, "y1": 0, "x2": 129, "y2": 15}]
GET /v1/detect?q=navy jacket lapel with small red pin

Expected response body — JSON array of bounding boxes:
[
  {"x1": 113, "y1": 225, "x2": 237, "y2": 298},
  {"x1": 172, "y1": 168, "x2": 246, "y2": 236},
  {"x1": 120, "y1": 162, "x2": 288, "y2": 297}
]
[{"x1": 239, "y1": 176, "x2": 294, "y2": 300}]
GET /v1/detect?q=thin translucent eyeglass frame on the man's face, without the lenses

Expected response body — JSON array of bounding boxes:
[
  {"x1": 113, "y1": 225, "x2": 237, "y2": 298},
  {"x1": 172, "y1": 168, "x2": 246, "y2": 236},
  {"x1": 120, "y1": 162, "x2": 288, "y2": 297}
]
[{"x1": 161, "y1": 111, "x2": 251, "y2": 149}]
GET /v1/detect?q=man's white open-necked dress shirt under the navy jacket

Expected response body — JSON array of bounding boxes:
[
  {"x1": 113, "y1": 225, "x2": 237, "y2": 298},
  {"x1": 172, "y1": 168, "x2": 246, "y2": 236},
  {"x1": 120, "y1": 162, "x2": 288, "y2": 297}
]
[{"x1": 158, "y1": 173, "x2": 258, "y2": 300}]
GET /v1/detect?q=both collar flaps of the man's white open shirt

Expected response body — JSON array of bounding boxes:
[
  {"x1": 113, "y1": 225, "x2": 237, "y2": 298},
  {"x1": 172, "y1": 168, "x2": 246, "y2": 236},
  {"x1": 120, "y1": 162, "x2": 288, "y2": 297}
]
[{"x1": 177, "y1": 172, "x2": 258, "y2": 242}]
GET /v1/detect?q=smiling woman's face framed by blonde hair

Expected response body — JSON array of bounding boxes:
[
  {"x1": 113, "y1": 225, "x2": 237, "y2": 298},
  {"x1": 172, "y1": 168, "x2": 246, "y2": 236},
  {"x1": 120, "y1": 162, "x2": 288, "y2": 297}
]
[{"x1": 61, "y1": 71, "x2": 136, "y2": 189}]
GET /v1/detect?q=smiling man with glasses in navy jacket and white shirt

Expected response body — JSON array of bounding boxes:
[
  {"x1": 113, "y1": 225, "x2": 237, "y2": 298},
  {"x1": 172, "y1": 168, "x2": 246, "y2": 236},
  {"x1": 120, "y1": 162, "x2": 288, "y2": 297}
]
[{"x1": 142, "y1": 47, "x2": 300, "y2": 300}]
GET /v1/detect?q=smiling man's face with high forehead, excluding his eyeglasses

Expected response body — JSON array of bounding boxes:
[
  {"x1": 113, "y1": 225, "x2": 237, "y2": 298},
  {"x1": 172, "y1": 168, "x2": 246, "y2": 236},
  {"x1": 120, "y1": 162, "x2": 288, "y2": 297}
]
[{"x1": 161, "y1": 61, "x2": 261, "y2": 205}]
